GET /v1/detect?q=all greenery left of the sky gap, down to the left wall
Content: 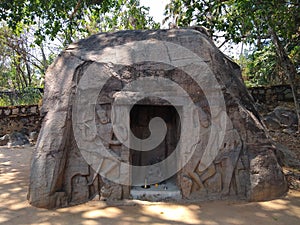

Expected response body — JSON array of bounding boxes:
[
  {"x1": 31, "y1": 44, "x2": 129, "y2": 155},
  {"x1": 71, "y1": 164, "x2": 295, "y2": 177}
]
[{"x1": 0, "y1": 0, "x2": 159, "y2": 105}]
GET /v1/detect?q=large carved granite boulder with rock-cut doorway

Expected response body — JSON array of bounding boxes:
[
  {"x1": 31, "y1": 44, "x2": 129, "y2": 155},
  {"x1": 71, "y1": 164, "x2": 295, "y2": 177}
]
[{"x1": 28, "y1": 29, "x2": 287, "y2": 208}]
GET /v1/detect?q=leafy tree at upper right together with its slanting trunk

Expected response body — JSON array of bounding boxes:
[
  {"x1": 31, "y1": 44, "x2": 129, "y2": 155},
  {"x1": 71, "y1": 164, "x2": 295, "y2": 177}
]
[{"x1": 165, "y1": 0, "x2": 300, "y2": 131}]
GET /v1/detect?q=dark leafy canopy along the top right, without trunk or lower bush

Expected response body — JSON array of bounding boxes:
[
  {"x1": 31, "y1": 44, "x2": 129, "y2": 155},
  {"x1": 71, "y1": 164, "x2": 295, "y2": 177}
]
[{"x1": 165, "y1": 0, "x2": 300, "y2": 43}]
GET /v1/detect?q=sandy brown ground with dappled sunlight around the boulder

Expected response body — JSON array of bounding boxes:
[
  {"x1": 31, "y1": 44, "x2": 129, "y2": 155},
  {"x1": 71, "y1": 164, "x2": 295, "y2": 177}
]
[{"x1": 0, "y1": 147, "x2": 300, "y2": 225}]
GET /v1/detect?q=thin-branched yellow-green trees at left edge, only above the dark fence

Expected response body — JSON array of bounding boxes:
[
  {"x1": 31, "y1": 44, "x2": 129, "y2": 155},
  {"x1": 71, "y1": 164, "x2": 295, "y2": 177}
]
[{"x1": 0, "y1": 24, "x2": 47, "y2": 91}]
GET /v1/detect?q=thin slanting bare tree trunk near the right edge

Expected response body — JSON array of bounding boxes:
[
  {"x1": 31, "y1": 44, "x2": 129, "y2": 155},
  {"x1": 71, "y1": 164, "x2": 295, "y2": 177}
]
[{"x1": 269, "y1": 26, "x2": 300, "y2": 132}]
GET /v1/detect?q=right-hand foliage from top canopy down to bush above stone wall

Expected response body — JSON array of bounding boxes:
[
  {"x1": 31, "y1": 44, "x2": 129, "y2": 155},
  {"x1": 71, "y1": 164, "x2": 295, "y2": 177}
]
[{"x1": 165, "y1": 0, "x2": 300, "y2": 85}]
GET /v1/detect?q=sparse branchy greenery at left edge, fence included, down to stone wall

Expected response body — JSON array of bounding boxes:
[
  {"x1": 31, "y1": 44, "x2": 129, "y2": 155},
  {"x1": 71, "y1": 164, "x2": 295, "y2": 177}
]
[{"x1": 0, "y1": 24, "x2": 48, "y2": 106}]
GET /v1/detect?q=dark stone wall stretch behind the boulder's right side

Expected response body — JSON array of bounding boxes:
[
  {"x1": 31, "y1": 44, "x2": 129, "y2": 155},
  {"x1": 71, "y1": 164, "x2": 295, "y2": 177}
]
[{"x1": 248, "y1": 85, "x2": 300, "y2": 103}]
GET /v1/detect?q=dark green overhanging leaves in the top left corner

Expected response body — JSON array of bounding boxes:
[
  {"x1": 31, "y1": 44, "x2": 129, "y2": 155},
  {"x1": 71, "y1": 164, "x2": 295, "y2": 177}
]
[{"x1": 0, "y1": 0, "x2": 118, "y2": 45}]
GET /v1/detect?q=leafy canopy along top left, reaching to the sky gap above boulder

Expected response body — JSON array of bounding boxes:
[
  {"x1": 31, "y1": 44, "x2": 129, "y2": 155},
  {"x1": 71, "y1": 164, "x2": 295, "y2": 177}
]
[{"x1": 0, "y1": 0, "x2": 159, "y2": 46}]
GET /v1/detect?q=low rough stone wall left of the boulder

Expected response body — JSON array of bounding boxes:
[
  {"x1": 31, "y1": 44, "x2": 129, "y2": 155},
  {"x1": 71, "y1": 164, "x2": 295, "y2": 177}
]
[{"x1": 0, "y1": 105, "x2": 42, "y2": 136}]
